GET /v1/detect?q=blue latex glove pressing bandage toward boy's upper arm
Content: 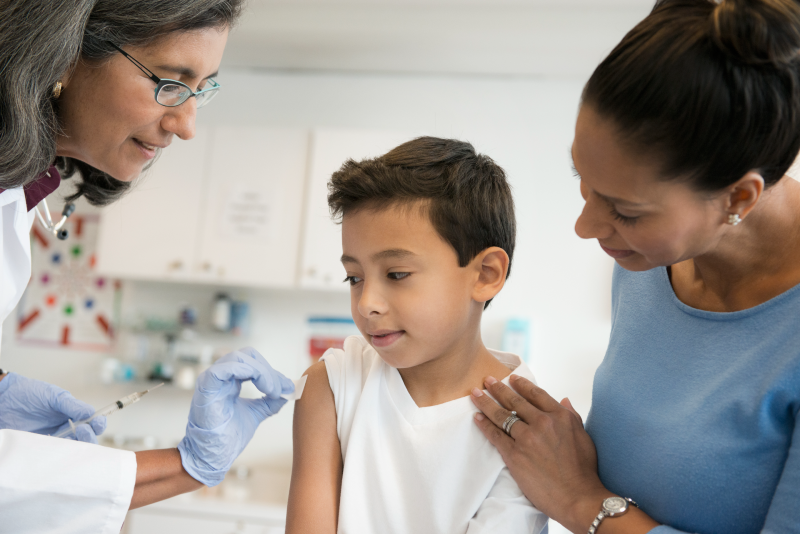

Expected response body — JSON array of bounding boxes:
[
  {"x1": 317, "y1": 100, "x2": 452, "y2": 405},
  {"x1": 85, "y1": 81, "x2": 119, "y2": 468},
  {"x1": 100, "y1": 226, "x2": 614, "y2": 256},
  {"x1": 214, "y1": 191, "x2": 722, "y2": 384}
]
[{"x1": 178, "y1": 347, "x2": 294, "y2": 486}]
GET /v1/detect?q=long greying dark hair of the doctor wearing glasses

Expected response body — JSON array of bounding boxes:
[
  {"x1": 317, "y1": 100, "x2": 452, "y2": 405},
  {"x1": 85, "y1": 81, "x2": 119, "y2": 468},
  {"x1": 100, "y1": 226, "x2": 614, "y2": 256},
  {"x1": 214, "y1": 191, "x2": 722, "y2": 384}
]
[{"x1": 0, "y1": 0, "x2": 244, "y2": 205}]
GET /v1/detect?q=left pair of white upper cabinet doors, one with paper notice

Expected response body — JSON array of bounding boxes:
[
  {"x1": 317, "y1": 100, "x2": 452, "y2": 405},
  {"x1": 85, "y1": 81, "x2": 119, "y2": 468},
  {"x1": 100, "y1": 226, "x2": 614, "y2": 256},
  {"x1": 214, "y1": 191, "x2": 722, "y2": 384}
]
[{"x1": 97, "y1": 127, "x2": 308, "y2": 287}]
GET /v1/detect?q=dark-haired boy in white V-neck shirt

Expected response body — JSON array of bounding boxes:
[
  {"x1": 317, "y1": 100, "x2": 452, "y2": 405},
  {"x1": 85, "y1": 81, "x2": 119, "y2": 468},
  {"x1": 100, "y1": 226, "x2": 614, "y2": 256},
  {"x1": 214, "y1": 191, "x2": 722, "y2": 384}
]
[{"x1": 286, "y1": 137, "x2": 547, "y2": 534}]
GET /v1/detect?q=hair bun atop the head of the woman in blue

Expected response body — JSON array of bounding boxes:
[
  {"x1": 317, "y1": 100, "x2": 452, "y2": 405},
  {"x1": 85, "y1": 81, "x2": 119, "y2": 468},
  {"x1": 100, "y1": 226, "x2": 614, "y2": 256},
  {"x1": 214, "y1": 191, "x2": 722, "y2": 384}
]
[{"x1": 711, "y1": 0, "x2": 800, "y2": 66}]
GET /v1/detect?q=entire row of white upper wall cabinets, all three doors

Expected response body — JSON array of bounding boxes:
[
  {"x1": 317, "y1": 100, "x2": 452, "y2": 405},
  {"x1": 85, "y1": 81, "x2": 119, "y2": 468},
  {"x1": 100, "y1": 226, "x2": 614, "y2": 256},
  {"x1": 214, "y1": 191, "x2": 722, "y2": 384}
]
[{"x1": 97, "y1": 127, "x2": 414, "y2": 291}]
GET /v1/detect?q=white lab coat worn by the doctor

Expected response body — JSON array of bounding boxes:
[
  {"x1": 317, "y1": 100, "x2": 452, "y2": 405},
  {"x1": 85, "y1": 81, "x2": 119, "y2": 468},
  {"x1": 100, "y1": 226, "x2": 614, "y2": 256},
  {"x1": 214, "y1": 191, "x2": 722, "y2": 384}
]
[{"x1": 0, "y1": 187, "x2": 136, "y2": 534}]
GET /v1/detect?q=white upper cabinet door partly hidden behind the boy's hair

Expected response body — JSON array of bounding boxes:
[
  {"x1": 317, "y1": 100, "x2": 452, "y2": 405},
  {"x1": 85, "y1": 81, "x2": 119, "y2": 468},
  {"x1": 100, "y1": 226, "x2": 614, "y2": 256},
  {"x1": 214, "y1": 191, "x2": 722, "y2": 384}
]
[{"x1": 300, "y1": 129, "x2": 416, "y2": 291}]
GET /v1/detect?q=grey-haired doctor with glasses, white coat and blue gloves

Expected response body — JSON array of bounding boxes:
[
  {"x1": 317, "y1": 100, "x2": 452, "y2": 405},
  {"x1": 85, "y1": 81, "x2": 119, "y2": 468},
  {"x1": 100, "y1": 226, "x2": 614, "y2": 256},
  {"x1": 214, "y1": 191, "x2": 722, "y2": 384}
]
[{"x1": 0, "y1": 0, "x2": 293, "y2": 534}]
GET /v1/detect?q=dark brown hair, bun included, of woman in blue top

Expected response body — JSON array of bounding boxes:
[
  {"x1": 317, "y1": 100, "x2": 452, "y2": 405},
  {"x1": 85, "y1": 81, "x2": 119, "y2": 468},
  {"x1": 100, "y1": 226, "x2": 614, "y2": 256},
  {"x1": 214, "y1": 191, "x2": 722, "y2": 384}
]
[{"x1": 583, "y1": 0, "x2": 800, "y2": 191}]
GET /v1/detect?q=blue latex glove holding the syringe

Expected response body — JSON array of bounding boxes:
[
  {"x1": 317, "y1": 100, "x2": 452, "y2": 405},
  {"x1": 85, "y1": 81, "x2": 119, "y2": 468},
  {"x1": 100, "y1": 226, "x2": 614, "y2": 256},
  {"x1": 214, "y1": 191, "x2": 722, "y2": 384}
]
[{"x1": 0, "y1": 373, "x2": 106, "y2": 443}]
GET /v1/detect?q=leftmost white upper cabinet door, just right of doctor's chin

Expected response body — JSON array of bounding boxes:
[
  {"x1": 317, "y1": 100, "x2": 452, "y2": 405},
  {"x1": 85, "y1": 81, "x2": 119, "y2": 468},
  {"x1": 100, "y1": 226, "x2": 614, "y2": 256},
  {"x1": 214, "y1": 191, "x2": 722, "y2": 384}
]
[{"x1": 97, "y1": 128, "x2": 210, "y2": 280}]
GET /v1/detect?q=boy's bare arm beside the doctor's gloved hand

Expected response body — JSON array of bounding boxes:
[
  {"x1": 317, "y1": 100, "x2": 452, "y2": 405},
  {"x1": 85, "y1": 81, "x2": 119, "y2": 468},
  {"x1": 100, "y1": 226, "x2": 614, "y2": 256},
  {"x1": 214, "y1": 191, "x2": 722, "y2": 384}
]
[{"x1": 286, "y1": 362, "x2": 344, "y2": 534}]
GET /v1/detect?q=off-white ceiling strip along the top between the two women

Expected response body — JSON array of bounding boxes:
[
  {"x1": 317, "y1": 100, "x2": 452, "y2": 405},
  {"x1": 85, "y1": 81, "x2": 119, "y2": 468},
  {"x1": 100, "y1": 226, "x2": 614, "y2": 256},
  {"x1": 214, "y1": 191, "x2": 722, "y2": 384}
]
[{"x1": 225, "y1": 0, "x2": 654, "y2": 79}]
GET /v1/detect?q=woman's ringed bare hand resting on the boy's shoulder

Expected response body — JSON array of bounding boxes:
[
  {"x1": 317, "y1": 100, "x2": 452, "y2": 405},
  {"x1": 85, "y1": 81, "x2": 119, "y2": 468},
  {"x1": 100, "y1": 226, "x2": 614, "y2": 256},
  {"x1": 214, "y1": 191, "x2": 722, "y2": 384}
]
[{"x1": 472, "y1": 375, "x2": 656, "y2": 532}]
